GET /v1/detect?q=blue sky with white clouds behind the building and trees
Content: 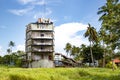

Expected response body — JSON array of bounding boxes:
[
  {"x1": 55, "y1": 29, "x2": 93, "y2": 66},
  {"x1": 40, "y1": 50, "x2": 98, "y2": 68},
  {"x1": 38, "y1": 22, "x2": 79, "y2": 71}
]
[{"x1": 0, "y1": 0, "x2": 106, "y2": 56}]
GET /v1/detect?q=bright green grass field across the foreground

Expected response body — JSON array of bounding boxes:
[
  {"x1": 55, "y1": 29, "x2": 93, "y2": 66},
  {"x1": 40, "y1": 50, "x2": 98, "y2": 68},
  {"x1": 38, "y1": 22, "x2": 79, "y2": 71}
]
[{"x1": 0, "y1": 67, "x2": 120, "y2": 80}]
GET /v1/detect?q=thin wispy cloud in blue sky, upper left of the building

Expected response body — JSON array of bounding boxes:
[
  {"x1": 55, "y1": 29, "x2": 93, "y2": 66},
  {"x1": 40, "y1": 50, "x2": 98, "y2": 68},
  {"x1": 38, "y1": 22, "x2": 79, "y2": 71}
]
[{"x1": 9, "y1": 7, "x2": 34, "y2": 16}]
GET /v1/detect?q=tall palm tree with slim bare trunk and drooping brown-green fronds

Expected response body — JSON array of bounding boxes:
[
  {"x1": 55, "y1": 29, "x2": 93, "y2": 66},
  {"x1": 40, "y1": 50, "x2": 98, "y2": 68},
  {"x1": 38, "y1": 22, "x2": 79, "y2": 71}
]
[{"x1": 84, "y1": 24, "x2": 98, "y2": 66}]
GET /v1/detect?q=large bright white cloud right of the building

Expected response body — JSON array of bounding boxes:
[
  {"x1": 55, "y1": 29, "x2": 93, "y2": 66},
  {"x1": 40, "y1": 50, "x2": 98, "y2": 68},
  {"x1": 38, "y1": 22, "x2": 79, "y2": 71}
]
[{"x1": 55, "y1": 22, "x2": 88, "y2": 54}]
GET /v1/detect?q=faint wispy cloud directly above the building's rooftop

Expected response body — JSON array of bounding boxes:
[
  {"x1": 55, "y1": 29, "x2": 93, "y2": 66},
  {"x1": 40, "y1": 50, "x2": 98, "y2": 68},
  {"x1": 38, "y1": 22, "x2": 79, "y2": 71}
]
[{"x1": 33, "y1": 8, "x2": 52, "y2": 19}]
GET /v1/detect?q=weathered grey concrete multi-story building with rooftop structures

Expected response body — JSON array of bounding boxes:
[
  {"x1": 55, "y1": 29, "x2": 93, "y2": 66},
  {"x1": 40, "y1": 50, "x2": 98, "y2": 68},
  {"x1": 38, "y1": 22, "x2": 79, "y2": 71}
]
[{"x1": 26, "y1": 18, "x2": 54, "y2": 67}]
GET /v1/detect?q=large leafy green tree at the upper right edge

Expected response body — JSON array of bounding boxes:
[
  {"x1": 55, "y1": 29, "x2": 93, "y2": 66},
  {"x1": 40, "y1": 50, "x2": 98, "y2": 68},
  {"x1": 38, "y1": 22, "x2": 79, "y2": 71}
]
[{"x1": 98, "y1": 0, "x2": 120, "y2": 70}]
